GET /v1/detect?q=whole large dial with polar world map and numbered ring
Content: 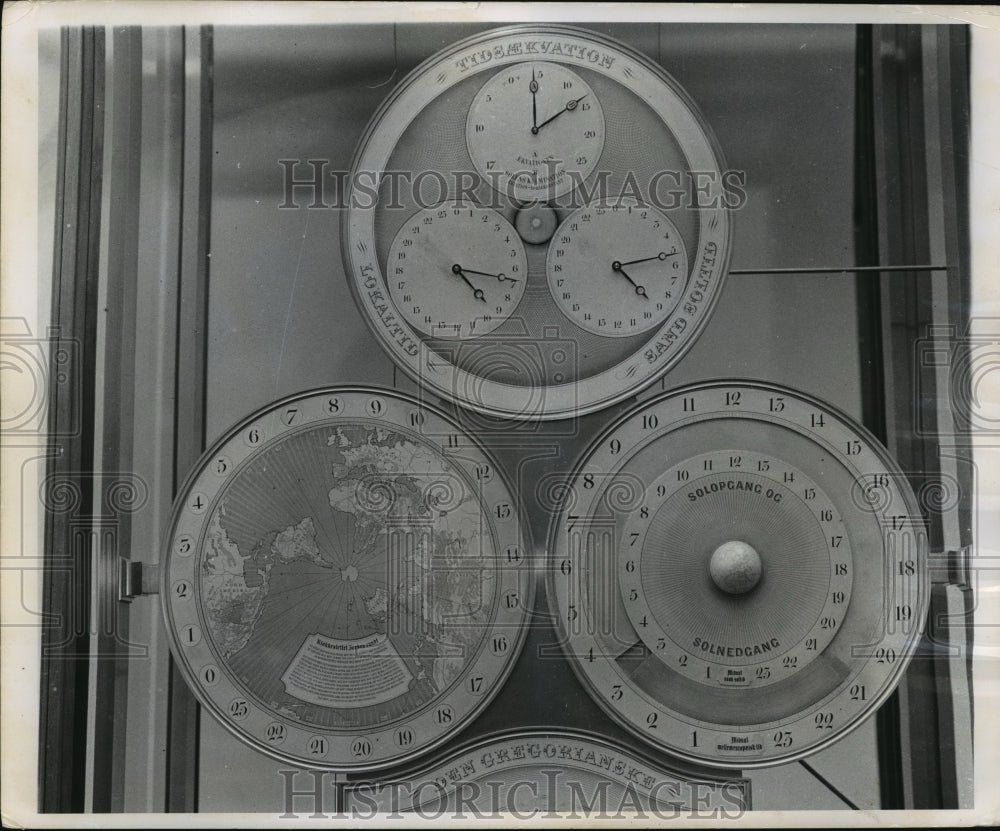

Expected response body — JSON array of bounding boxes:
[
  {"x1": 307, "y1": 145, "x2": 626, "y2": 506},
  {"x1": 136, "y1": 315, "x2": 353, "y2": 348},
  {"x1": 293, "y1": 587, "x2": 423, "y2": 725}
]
[{"x1": 161, "y1": 388, "x2": 533, "y2": 770}]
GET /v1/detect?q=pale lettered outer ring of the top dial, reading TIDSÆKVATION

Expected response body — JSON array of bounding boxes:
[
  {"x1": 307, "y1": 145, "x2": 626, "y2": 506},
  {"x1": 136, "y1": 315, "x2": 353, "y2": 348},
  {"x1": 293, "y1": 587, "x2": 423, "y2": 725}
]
[{"x1": 341, "y1": 25, "x2": 732, "y2": 420}]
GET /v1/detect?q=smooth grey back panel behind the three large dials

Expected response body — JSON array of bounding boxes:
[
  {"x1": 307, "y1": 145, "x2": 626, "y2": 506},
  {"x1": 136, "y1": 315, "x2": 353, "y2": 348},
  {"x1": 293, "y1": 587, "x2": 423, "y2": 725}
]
[{"x1": 199, "y1": 25, "x2": 878, "y2": 811}]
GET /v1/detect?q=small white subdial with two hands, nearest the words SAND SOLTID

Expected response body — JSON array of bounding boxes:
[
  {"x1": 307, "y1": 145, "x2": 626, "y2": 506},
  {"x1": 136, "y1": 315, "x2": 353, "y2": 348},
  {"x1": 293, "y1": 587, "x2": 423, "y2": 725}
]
[{"x1": 545, "y1": 200, "x2": 688, "y2": 337}]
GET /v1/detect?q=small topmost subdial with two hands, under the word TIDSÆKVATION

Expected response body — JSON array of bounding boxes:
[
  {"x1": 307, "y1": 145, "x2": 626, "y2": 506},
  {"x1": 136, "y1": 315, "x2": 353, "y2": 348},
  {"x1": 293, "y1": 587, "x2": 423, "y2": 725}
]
[{"x1": 465, "y1": 61, "x2": 604, "y2": 201}]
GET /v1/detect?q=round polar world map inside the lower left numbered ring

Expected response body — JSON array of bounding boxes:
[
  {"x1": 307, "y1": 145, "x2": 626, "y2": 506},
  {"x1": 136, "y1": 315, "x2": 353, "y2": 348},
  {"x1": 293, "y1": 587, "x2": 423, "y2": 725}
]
[{"x1": 201, "y1": 425, "x2": 494, "y2": 728}]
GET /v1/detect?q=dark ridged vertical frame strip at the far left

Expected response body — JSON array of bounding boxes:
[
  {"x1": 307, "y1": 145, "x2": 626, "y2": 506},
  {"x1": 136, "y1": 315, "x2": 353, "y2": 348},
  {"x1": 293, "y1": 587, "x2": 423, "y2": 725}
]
[{"x1": 39, "y1": 28, "x2": 104, "y2": 811}]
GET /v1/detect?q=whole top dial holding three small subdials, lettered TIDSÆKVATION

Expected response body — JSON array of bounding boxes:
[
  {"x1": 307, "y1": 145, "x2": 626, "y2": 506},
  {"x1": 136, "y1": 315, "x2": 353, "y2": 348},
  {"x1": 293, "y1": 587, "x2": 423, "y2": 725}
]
[{"x1": 342, "y1": 26, "x2": 731, "y2": 419}]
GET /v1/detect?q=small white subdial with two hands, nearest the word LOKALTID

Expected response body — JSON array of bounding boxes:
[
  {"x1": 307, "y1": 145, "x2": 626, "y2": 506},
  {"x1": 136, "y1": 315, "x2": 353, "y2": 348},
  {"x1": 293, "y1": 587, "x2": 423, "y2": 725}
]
[{"x1": 386, "y1": 203, "x2": 528, "y2": 338}]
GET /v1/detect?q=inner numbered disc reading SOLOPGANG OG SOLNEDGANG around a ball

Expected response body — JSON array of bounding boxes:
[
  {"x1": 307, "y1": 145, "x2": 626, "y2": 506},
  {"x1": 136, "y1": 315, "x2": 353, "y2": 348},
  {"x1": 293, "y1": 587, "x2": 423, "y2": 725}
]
[{"x1": 619, "y1": 449, "x2": 853, "y2": 687}]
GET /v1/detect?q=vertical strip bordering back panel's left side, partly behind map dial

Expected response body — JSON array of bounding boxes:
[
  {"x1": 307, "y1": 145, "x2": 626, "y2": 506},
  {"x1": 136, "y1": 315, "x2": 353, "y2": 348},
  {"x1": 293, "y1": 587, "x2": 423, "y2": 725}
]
[{"x1": 167, "y1": 26, "x2": 213, "y2": 811}]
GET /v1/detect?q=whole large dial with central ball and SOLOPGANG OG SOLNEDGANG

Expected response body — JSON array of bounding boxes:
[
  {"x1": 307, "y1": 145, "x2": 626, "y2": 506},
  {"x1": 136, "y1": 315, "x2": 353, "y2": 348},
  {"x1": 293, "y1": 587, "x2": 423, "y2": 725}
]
[{"x1": 547, "y1": 381, "x2": 929, "y2": 768}]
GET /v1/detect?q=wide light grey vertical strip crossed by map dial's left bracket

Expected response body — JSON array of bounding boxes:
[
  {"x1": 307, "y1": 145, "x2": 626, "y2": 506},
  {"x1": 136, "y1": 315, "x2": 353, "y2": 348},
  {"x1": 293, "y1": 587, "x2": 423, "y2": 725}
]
[{"x1": 121, "y1": 19, "x2": 180, "y2": 812}]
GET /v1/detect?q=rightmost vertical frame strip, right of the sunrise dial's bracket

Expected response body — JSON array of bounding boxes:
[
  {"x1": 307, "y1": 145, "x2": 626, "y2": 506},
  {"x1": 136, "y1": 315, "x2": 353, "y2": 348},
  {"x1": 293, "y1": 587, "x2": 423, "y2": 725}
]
[{"x1": 921, "y1": 26, "x2": 974, "y2": 808}]
